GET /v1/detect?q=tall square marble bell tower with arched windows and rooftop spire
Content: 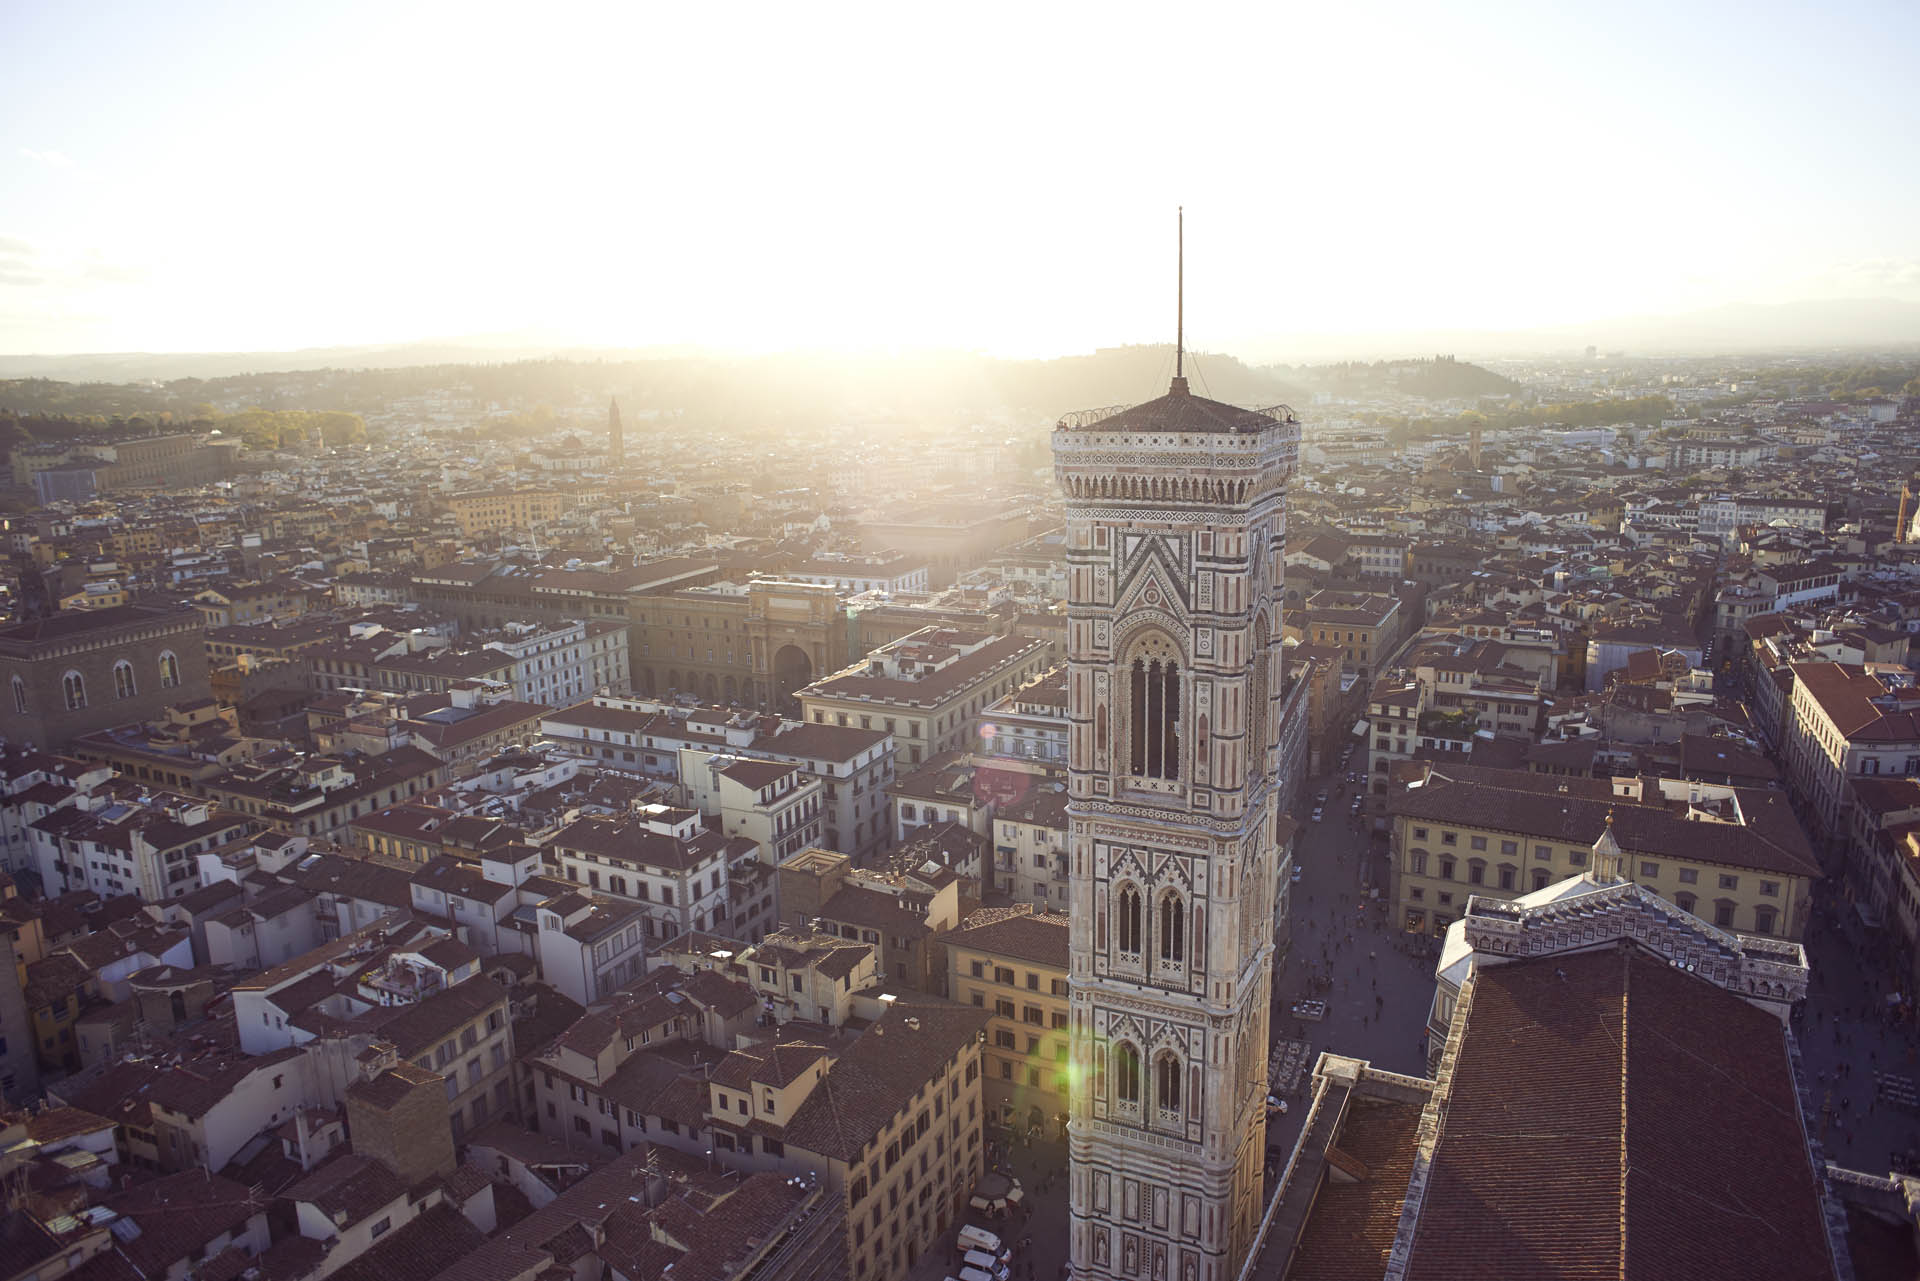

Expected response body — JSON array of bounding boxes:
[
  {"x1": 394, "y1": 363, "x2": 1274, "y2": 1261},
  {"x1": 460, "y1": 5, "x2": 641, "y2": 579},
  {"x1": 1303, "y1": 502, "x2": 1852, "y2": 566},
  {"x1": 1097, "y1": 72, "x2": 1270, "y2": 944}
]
[{"x1": 1054, "y1": 217, "x2": 1300, "y2": 1281}]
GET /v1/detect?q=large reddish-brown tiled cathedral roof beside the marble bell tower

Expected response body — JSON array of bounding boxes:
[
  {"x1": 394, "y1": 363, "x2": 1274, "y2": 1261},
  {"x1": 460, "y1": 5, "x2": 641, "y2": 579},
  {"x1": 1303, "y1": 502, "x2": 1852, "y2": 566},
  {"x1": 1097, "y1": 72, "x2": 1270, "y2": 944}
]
[{"x1": 1407, "y1": 945, "x2": 1836, "y2": 1281}]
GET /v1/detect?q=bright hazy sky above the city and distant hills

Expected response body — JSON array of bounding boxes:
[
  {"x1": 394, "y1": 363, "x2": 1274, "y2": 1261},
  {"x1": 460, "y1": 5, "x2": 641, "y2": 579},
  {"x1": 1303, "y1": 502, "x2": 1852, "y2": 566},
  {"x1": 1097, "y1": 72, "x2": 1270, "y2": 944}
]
[{"x1": 0, "y1": 0, "x2": 1920, "y2": 355}]
